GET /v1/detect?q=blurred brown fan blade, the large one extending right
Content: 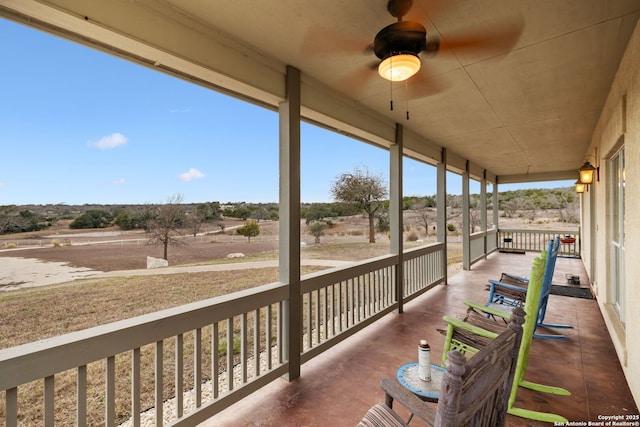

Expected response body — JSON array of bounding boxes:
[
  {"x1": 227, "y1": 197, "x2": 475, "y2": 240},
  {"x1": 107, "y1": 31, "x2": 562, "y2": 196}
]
[{"x1": 437, "y1": 21, "x2": 524, "y2": 54}]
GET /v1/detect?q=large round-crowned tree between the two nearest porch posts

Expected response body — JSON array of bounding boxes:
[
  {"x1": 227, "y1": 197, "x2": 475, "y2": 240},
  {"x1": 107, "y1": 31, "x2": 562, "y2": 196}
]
[{"x1": 331, "y1": 168, "x2": 387, "y2": 243}]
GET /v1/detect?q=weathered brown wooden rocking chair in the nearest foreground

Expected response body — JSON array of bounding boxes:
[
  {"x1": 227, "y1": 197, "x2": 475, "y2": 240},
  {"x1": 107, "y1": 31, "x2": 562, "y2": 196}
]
[{"x1": 358, "y1": 308, "x2": 524, "y2": 427}]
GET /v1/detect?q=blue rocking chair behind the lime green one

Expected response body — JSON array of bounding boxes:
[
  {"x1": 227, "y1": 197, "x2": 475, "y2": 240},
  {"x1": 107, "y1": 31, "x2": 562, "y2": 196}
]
[{"x1": 478, "y1": 236, "x2": 573, "y2": 339}]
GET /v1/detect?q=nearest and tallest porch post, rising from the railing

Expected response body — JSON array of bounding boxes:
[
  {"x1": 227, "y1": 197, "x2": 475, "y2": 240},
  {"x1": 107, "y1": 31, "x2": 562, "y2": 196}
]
[{"x1": 278, "y1": 66, "x2": 302, "y2": 381}]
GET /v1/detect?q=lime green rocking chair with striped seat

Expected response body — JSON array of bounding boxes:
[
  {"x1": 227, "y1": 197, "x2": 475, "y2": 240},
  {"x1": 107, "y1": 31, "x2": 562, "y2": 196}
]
[{"x1": 443, "y1": 252, "x2": 571, "y2": 423}]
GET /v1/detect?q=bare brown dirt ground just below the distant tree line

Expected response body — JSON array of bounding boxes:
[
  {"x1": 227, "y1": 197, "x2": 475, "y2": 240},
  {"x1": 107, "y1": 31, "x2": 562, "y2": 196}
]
[{"x1": 0, "y1": 212, "x2": 570, "y2": 280}]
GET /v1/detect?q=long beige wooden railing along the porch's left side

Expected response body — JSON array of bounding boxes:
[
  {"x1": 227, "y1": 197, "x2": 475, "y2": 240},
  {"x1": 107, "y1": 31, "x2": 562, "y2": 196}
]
[{"x1": 0, "y1": 243, "x2": 446, "y2": 427}]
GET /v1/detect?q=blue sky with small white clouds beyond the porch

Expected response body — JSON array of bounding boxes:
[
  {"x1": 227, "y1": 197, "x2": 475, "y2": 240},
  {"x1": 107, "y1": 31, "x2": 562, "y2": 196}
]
[{"x1": 0, "y1": 18, "x2": 572, "y2": 206}]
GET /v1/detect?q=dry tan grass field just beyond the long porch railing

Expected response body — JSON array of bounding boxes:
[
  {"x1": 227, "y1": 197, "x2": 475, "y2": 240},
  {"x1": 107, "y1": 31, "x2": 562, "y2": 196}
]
[{"x1": 0, "y1": 242, "x2": 461, "y2": 425}]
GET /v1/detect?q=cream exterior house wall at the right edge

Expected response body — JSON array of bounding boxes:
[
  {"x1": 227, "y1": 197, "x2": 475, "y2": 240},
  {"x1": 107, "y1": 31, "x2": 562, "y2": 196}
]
[{"x1": 582, "y1": 22, "x2": 640, "y2": 402}]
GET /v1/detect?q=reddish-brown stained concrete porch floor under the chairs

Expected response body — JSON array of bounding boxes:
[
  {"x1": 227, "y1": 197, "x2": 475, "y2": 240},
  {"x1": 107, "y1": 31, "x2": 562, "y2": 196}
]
[{"x1": 201, "y1": 253, "x2": 638, "y2": 427}]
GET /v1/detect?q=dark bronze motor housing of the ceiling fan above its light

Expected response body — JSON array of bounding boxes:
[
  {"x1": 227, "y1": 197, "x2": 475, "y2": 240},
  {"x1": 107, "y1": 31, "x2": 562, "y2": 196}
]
[{"x1": 373, "y1": 21, "x2": 427, "y2": 59}]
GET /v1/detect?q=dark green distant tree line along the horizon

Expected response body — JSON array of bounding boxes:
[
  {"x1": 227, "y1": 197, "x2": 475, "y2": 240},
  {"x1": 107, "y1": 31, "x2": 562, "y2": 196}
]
[{"x1": 0, "y1": 187, "x2": 580, "y2": 238}]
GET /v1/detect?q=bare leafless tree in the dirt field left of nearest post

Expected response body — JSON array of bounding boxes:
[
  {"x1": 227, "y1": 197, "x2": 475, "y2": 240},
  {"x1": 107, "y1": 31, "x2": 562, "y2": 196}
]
[{"x1": 149, "y1": 194, "x2": 186, "y2": 260}]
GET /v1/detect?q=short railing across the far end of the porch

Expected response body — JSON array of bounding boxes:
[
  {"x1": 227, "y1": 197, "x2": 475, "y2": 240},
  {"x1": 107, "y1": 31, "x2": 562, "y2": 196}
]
[{"x1": 498, "y1": 228, "x2": 580, "y2": 258}]
